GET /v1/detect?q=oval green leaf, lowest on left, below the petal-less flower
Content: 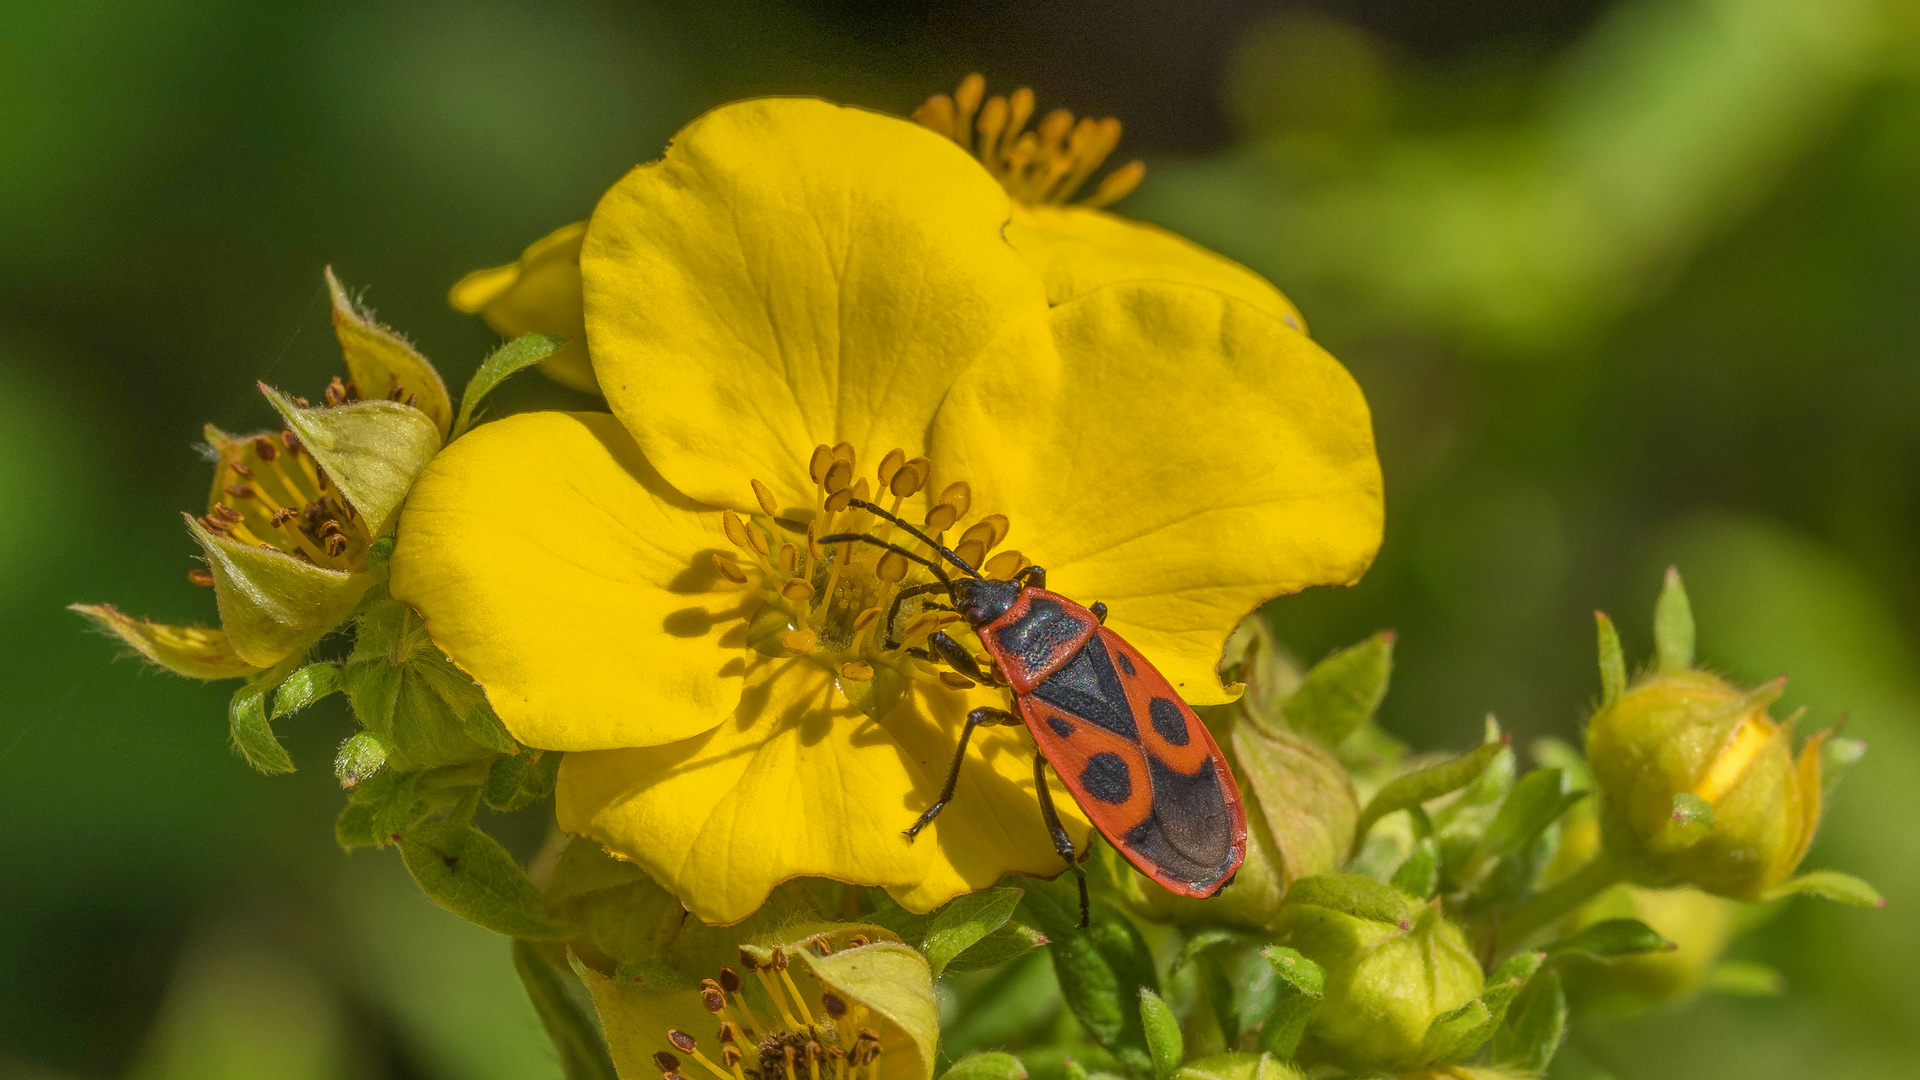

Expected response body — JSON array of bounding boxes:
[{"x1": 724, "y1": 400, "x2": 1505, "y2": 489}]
[{"x1": 399, "y1": 815, "x2": 572, "y2": 940}]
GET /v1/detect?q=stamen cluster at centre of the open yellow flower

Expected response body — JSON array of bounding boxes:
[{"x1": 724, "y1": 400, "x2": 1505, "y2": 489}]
[{"x1": 714, "y1": 442, "x2": 1027, "y2": 711}]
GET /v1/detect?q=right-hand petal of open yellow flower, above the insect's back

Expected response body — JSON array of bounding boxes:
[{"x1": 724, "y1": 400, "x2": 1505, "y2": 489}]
[{"x1": 931, "y1": 282, "x2": 1382, "y2": 705}]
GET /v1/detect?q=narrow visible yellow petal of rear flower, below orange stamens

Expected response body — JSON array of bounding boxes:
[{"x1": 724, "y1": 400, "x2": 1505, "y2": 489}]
[{"x1": 1006, "y1": 204, "x2": 1308, "y2": 332}]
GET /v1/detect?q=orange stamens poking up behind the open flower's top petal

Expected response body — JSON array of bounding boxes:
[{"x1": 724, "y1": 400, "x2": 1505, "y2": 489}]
[{"x1": 914, "y1": 75, "x2": 1146, "y2": 208}]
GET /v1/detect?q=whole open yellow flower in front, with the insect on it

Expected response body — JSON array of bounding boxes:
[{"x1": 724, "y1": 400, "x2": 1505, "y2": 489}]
[{"x1": 392, "y1": 100, "x2": 1380, "y2": 922}]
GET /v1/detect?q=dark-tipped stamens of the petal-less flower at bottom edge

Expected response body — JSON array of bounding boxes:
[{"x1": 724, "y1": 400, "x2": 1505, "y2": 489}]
[{"x1": 653, "y1": 934, "x2": 881, "y2": 1080}]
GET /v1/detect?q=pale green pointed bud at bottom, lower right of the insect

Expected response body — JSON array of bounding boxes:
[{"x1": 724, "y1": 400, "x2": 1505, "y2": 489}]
[{"x1": 1281, "y1": 876, "x2": 1484, "y2": 1072}]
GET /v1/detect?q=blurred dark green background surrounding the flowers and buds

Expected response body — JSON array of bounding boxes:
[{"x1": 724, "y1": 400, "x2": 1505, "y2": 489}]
[{"x1": 0, "y1": 0, "x2": 1920, "y2": 1080}]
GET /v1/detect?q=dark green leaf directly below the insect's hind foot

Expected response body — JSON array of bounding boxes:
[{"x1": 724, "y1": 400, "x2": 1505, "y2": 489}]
[{"x1": 1023, "y1": 878, "x2": 1160, "y2": 1074}]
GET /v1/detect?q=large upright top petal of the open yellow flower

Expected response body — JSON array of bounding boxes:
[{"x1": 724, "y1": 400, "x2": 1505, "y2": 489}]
[{"x1": 580, "y1": 98, "x2": 1046, "y2": 509}]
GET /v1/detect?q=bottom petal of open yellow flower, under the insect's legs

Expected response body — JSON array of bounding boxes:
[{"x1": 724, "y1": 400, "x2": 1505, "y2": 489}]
[{"x1": 555, "y1": 657, "x2": 1087, "y2": 924}]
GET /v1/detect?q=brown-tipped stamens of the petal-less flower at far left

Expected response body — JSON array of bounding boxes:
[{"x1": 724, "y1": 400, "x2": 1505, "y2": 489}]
[{"x1": 188, "y1": 379, "x2": 372, "y2": 584}]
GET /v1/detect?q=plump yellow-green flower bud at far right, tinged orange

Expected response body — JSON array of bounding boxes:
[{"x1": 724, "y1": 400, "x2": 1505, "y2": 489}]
[{"x1": 1586, "y1": 669, "x2": 1822, "y2": 899}]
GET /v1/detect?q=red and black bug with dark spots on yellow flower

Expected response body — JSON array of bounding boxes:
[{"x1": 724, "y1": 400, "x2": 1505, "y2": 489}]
[{"x1": 820, "y1": 500, "x2": 1246, "y2": 926}]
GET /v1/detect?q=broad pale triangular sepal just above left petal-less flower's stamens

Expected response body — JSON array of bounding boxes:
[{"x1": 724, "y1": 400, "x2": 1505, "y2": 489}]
[{"x1": 259, "y1": 382, "x2": 440, "y2": 536}]
